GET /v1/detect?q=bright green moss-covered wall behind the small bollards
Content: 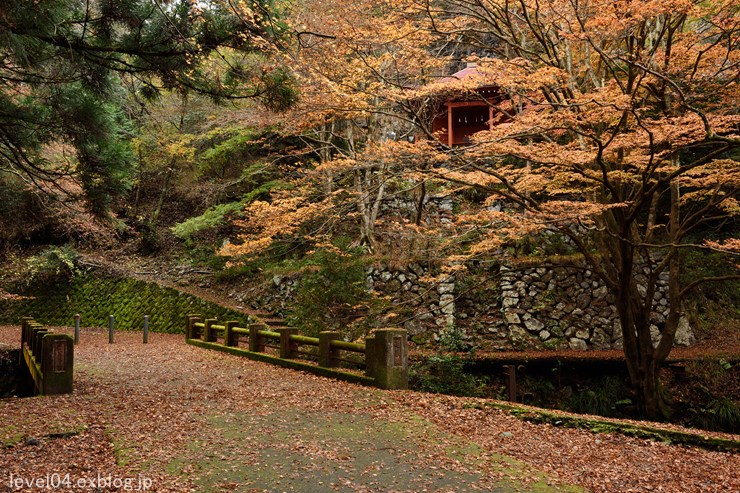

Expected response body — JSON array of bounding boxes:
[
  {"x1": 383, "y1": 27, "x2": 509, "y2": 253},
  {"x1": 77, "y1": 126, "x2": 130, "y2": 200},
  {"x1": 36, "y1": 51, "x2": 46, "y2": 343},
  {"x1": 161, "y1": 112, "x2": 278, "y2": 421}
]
[{"x1": 0, "y1": 273, "x2": 249, "y2": 333}]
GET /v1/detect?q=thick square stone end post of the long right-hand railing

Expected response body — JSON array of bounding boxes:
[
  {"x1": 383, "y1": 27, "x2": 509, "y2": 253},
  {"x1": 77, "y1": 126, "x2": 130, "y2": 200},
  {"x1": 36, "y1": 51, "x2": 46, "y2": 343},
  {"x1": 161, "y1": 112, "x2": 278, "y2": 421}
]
[{"x1": 365, "y1": 329, "x2": 409, "y2": 389}]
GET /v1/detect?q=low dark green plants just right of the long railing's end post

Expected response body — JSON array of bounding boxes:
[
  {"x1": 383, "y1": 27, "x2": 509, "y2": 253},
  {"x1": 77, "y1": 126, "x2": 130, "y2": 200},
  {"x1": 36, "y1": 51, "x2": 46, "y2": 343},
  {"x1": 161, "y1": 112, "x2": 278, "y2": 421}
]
[{"x1": 409, "y1": 354, "x2": 488, "y2": 397}]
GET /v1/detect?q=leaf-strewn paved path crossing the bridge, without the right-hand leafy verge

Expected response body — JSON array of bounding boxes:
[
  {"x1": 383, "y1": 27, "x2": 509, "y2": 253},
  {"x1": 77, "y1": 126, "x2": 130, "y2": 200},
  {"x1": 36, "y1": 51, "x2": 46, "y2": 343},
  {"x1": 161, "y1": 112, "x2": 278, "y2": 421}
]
[{"x1": 0, "y1": 326, "x2": 579, "y2": 492}]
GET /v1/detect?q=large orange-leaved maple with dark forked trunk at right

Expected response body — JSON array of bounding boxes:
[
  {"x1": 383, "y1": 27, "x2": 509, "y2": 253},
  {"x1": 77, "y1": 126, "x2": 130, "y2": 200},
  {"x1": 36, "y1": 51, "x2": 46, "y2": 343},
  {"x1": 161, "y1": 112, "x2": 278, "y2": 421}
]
[{"x1": 418, "y1": 0, "x2": 740, "y2": 417}]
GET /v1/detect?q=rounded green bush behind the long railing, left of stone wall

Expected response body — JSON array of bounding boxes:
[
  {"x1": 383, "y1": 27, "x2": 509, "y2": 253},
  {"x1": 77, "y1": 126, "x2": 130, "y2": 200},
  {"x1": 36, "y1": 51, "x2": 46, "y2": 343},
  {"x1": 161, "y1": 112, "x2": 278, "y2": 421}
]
[{"x1": 287, "y1": 249, "x2": 372, "y2": 335}]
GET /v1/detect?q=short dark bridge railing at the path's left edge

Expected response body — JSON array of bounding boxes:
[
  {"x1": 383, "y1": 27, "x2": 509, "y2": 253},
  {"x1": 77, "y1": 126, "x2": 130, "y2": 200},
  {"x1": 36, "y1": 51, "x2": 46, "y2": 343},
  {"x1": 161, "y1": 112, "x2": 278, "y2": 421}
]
[{"x1": 20, "y1": 318, "x2": 74, "y2": 395}]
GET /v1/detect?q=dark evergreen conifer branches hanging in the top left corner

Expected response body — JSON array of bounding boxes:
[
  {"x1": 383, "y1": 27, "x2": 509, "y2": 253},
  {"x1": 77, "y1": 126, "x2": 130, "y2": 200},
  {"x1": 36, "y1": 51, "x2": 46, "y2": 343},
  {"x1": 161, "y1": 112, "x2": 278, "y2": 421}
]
[{"x1": 0, "y1": 0, "x2": 295, "y2": 215}]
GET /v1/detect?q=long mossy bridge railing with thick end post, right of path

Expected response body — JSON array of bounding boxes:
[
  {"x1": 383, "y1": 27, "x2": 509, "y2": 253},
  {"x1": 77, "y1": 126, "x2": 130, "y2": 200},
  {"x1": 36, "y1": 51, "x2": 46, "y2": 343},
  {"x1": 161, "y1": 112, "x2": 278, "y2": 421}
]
[{"x1": 185, "y1": 315, "x2": 408, "y2": 389}]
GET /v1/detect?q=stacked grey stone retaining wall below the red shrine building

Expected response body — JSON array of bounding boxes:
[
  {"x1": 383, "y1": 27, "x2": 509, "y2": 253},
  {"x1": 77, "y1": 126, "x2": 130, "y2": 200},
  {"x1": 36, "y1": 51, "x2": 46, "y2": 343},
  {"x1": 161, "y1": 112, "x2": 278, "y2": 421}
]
[{"x1": 264, "y1": 264, "x2": 696, "y2": 350}]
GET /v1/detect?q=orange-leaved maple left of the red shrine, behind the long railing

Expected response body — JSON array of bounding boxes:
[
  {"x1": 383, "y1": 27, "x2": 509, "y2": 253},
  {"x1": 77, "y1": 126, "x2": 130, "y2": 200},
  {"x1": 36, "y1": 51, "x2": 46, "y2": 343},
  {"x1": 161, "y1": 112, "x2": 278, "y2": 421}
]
[{"x1": 222, "y1": 0, "x2": 446, "y2": 257}]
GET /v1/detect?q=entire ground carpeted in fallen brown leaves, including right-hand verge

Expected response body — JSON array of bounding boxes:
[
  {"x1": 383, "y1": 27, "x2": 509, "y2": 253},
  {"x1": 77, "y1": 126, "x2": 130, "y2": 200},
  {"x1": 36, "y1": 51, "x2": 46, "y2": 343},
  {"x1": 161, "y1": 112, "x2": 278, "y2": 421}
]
[{"x1": 0, "y1": 327, "x2": 740, "y2": 492}]
